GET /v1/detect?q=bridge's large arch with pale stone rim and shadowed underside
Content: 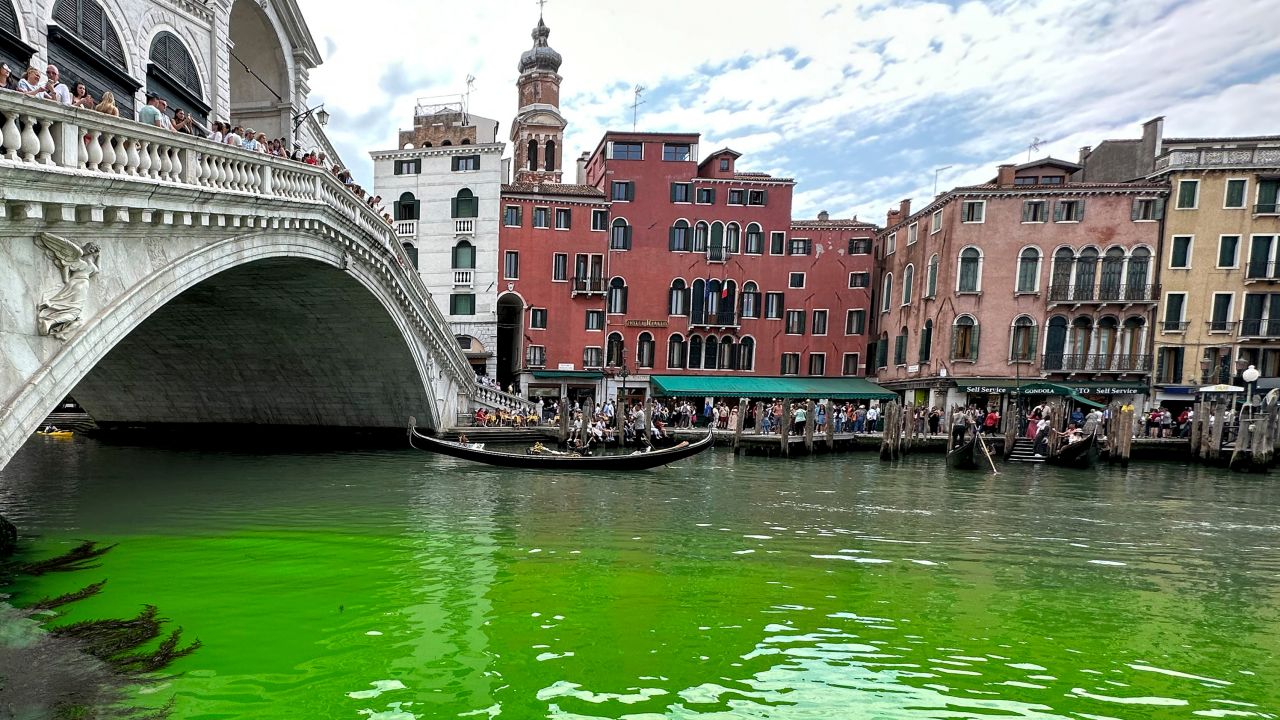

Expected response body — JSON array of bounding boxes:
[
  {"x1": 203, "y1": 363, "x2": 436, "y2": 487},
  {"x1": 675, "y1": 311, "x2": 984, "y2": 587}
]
[{"x1": 0, "y1": 231, "x2": 449, "y2": 466}]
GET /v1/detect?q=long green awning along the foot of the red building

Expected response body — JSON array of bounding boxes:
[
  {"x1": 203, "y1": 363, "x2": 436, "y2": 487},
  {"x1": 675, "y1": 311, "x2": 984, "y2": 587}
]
[{"x1": 649, "y1": 375, "x2": 897, "y2": 400}]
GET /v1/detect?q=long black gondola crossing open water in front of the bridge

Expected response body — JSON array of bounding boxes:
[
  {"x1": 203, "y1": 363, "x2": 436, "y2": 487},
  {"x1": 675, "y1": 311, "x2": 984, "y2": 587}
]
[{"x1": 408, "y1": 421, "x2": 713, "y2": 471}]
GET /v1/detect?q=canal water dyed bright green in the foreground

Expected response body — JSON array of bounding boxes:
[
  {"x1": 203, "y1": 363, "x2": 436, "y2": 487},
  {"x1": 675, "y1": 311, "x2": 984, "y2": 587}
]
[{"x1": 0, "y1": 438, "x2": 1280, "y2": 720}]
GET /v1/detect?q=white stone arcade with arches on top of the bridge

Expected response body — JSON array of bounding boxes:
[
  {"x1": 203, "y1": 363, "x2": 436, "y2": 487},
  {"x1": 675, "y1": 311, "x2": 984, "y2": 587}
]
[{"x1": 0, "y1": 0, "x2": 321, "y2": 145}]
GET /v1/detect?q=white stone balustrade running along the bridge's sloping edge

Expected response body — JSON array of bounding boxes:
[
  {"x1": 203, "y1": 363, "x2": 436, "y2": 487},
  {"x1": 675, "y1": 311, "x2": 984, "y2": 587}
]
[{"x1": 0, "y1": 92, "x2": 476, "y2": 395}]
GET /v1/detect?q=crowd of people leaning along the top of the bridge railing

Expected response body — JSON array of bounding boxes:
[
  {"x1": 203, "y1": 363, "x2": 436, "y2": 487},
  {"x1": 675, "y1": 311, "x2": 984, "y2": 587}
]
[{"x1": 0, "y1": 63, "x2": 392, "y2": 225}]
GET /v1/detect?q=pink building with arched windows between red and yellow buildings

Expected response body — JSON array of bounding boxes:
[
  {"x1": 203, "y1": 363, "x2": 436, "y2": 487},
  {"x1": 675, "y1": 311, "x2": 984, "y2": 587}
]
[{"x1": 872, "y1": 159, "x2": 1167, "y2": 410}]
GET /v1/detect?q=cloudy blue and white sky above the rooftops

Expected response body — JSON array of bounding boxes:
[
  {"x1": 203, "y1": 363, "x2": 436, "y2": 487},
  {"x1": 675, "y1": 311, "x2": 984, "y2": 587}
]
[{"x1": 298, "y1": 0, "x2": 1280, "y2": 222}]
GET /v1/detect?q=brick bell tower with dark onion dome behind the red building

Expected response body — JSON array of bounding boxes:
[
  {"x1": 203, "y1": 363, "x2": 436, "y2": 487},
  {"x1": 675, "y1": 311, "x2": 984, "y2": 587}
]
[{"x1": 511, "y1": 13, "x2": 567, "y2": 183}]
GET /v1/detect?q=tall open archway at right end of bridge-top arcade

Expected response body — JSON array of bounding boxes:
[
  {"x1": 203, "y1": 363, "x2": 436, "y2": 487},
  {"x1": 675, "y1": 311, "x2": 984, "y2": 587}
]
[{"x1": 229, "y1": 0, "x2": 292, "y2": 137}]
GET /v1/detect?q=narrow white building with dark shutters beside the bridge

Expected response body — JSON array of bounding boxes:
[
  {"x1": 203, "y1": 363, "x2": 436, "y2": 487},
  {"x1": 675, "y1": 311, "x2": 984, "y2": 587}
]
[{"x1": 370, "y1": 101, "x2": 507, "y2": 377}]
